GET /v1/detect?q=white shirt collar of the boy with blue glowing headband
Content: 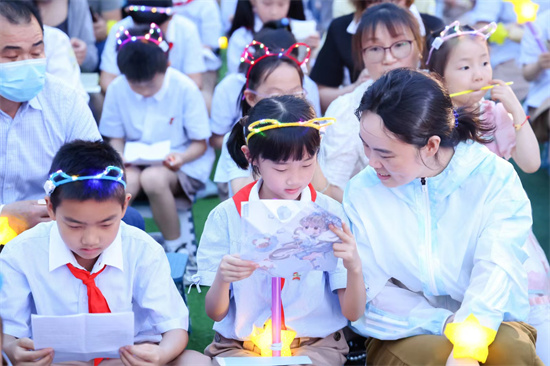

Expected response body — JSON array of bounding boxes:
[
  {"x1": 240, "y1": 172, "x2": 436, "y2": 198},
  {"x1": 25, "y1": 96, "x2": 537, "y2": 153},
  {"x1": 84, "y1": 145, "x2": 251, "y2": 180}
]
[{"x1": 49, "y1": 224, "x2": 124, "y2": 273}]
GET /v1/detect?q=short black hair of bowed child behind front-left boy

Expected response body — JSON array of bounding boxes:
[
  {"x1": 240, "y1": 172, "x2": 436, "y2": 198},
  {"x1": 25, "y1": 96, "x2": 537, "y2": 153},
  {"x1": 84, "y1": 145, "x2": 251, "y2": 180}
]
[{"x1": 117, "y1": 26, "x2": 168, "y2": 82}]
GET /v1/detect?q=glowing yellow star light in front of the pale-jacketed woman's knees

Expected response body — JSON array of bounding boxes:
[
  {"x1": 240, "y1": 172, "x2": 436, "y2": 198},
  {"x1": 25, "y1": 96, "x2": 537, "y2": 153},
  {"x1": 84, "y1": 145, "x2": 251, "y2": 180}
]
[{"x1": 445, "y1": 314, "x2": 497, "y2": 362}]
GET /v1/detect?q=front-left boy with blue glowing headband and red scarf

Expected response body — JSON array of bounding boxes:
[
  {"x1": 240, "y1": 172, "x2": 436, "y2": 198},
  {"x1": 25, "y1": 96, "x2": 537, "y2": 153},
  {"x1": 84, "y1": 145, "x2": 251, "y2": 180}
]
[{"x1": 0, "y1": 141, "x2": 210, "y2": 365}]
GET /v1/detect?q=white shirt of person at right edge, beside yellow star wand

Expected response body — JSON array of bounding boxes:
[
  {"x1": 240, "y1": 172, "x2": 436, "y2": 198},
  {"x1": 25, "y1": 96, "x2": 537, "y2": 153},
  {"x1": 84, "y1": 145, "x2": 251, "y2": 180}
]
[{"x1": 519, "y1": 10, "x2": 550, "y2": 108}]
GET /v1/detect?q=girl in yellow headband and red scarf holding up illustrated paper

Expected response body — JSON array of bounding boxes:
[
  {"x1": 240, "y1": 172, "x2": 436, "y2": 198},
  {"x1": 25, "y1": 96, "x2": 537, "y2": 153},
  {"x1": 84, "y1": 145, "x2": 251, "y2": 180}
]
[{"x1": 197, "y1": 95, "x2": 366, "y2": 365}]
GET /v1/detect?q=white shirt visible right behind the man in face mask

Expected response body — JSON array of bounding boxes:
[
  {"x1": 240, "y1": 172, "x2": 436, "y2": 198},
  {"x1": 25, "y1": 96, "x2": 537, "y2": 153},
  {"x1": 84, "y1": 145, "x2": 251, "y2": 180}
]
[{"x1": 44, "y1": 25, "x2": 90, "y2": 103}]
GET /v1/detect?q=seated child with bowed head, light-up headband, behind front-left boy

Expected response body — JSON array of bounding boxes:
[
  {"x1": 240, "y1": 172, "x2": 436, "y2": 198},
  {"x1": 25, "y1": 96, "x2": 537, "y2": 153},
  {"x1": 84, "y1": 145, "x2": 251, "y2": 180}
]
[{"x1": 99, "y1": 23, "x2": 214, "y2": 252}]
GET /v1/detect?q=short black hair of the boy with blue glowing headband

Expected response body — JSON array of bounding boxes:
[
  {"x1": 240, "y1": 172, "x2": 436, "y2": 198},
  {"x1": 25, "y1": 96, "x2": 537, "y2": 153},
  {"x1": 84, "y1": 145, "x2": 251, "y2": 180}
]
[{"x1": 50, "y1": 140, "x2": 126, "y2": 212}]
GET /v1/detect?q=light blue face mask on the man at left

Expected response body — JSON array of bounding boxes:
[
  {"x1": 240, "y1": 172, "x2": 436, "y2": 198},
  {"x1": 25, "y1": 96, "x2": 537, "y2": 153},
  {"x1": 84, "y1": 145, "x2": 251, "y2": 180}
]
[{"x1": 0, "y1": 58, "x2": 46, "y2": 102}]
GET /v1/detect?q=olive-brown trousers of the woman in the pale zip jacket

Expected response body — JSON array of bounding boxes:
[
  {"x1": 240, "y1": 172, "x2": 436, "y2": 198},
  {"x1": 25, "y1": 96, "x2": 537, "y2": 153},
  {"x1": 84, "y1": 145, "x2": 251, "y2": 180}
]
[{"x1": 367, "y1": 322, "x2": 544, "y2": 366}]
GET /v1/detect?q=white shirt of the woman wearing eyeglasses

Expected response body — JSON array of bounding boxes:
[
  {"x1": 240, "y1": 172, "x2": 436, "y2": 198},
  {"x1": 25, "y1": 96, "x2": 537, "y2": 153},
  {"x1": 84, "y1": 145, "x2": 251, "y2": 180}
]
[{"x1": 319, "y1": 80, "x2": 373, "y2": 190}]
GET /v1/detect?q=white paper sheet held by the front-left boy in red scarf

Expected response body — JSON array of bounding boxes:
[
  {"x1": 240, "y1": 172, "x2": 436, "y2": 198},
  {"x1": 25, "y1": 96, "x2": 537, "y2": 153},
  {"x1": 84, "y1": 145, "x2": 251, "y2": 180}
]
[{"x1": 31, "y1": 312, "x2": 134, "y2": 363}]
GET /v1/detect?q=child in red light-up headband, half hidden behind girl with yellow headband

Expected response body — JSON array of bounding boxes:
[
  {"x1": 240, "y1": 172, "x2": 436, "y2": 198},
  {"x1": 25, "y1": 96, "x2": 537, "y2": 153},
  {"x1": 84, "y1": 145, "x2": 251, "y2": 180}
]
[{"x1": 210, "y1": 29, "x2": 319, "y2": 198}]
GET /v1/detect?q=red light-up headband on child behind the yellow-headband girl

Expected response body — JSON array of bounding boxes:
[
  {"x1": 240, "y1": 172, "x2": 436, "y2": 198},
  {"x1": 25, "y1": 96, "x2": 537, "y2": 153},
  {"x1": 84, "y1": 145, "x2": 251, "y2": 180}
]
[{"x1": 241, "y1": 41, "x2": 311, "y2": 89}]
